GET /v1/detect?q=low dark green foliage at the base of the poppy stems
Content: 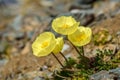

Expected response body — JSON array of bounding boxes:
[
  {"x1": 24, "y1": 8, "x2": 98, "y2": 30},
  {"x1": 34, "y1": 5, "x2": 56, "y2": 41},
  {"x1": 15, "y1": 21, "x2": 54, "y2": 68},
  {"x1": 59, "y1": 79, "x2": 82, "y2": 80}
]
[{"x1": 54, "y1": 49, "x2": 120, "y2": 80}]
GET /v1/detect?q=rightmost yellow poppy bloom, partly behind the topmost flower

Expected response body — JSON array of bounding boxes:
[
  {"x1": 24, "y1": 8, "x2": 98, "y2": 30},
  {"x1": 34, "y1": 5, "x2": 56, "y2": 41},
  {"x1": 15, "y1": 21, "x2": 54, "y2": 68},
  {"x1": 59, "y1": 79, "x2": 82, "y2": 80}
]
[{"x1": 68, "y1": 26, "x2": 92, "y2": 46}]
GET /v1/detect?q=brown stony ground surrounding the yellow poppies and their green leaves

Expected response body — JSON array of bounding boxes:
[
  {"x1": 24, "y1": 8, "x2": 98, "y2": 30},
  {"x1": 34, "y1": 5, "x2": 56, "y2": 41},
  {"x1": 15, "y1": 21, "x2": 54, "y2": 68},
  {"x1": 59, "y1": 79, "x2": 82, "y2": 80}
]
[{"x1": 0, "y1": 0, "x2": 120, "y2": 80}]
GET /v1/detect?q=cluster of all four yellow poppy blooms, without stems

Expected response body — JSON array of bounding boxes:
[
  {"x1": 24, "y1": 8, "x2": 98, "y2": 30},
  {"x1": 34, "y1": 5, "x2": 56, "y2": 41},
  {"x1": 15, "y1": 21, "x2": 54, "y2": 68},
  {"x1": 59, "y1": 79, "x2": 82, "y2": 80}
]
[{"x1": 32, "y1": 16, "x2": 92, "y2": 57}]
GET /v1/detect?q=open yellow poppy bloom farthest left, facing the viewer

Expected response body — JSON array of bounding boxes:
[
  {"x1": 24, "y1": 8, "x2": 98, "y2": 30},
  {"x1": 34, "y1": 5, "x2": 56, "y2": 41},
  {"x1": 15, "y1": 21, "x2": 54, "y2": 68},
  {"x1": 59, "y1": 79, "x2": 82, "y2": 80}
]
[{"x1": 32, "y1": 32, "x2": 56, "y2": 57}]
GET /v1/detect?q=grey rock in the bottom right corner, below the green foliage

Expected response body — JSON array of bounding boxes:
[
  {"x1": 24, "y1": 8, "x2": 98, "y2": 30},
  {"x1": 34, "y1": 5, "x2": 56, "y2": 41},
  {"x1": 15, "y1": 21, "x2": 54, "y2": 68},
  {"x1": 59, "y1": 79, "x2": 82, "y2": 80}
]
[{"x1": 90, "y1": 68, "x2": 120, "y2": 80}]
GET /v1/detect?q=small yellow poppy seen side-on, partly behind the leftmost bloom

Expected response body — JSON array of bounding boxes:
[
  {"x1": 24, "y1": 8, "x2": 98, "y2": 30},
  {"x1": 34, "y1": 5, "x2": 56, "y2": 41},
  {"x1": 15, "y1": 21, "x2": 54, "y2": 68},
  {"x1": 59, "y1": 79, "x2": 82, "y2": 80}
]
[{"x1": 53, "y1": 37, "x2": 64, "y2": 53}]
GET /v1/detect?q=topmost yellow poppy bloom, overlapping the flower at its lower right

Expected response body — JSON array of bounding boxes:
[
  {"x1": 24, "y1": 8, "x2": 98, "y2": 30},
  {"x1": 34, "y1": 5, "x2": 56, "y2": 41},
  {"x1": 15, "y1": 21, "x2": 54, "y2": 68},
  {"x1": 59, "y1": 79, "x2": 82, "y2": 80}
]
[{"x1": 52, "y1": 16, "x2": 79, "y2": 35}]
